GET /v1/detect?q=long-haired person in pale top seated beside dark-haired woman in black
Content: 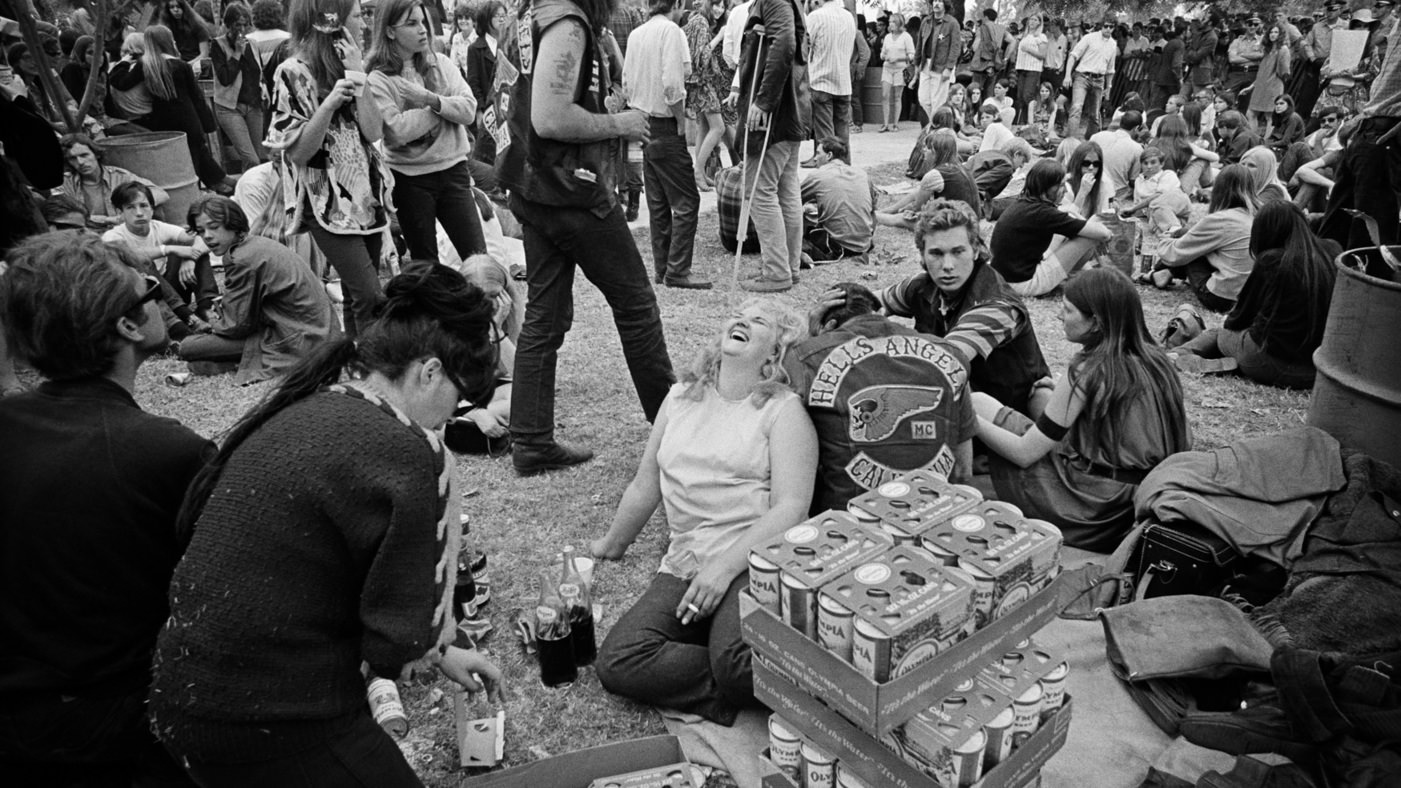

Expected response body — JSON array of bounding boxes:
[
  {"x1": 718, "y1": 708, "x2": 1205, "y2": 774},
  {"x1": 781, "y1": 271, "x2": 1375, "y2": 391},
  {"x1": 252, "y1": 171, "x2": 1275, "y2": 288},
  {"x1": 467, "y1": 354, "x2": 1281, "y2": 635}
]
[{"x1": 1152, "y1": 164, "x2": 1259, "y2": 313}]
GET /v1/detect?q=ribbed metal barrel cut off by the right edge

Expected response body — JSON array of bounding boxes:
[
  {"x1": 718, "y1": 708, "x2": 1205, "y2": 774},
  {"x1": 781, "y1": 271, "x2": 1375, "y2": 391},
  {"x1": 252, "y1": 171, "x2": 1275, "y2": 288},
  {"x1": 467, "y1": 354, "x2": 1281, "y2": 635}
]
[{"x1": 1309, "y1": 247, "x2": 1401, "y2": 468}]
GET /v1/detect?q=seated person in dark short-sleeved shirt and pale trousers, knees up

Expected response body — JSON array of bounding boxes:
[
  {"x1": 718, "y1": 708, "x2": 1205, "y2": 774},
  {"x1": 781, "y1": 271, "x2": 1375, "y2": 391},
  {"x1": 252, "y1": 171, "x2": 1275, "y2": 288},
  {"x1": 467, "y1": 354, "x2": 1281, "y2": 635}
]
[{"x1": 992, "y1": 158, "x2": 1111, "y2": 297}]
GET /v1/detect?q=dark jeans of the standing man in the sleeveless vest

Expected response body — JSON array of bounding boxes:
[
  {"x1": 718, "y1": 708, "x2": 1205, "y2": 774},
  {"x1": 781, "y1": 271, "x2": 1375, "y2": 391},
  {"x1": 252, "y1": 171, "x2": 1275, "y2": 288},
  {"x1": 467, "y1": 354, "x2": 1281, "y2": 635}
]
[{"x1": 511, "y1": 195, "x2": 675, "y2": 444}]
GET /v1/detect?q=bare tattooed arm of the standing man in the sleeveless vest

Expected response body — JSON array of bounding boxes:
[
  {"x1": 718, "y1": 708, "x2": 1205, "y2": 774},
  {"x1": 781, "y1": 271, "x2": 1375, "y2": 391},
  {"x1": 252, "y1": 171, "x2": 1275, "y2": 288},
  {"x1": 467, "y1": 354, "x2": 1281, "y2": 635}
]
[{"x1": 531, "y1": 18, "x2": 647, "y2": 142}]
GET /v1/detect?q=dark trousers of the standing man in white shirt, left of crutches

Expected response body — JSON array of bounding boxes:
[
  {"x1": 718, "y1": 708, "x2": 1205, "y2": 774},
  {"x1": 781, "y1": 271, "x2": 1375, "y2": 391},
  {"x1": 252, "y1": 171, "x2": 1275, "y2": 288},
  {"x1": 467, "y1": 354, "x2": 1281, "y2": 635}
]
[{"x1": 642, "y1": 118, "x2": 701, "y2": 283}]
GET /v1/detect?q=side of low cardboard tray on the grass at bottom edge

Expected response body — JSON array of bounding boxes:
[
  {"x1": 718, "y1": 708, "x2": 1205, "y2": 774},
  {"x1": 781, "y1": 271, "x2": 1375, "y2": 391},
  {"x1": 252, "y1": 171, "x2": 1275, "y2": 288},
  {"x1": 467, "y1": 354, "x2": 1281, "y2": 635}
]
[{"x1": 460, "y1": 736, "x2": 686, "y2": 788}]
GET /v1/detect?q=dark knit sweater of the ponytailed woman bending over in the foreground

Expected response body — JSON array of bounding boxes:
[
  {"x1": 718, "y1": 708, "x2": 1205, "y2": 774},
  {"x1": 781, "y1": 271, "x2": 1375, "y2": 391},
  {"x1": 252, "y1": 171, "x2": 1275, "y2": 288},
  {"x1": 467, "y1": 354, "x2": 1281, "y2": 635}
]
[{"x1": 151, "y1": 391, "x2": 455, "y2": 763}]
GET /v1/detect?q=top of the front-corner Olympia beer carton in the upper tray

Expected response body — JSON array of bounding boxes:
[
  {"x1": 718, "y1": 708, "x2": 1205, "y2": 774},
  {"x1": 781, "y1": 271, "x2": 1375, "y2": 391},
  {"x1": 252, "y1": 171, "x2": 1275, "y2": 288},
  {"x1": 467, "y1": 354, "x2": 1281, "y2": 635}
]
[{"x1": 821, "y1": 547, "x2": 972, "y2": 635}]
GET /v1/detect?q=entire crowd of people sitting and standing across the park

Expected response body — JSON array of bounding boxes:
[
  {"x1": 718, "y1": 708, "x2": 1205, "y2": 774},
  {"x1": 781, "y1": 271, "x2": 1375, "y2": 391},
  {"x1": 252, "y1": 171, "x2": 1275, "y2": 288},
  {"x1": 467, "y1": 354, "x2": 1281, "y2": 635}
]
[{"x1": 0, "y1": 0, "x2": 1401, "y2": 787}]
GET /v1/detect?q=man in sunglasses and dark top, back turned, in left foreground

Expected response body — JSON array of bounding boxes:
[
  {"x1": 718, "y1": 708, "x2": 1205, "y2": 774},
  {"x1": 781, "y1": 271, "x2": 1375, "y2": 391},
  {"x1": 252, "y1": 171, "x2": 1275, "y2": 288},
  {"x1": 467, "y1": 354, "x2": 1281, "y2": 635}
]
[{"x1": 0, "y1": 233, "x2": 214, "y2": 785}]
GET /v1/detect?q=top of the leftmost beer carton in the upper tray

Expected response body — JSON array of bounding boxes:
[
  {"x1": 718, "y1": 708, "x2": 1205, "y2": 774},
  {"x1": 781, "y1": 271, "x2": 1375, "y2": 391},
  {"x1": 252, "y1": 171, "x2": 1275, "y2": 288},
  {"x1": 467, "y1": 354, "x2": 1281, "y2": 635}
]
[{"x1": 751, "y1": 512, "x2": 890, "y2": 589}]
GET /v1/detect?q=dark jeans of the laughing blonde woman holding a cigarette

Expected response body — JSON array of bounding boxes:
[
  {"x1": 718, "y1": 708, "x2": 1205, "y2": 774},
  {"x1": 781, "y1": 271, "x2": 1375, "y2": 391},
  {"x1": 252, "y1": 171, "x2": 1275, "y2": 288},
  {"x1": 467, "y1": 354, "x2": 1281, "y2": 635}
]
[{"x1": 594, "y1": 572, "x2": 754, "y2": 725}]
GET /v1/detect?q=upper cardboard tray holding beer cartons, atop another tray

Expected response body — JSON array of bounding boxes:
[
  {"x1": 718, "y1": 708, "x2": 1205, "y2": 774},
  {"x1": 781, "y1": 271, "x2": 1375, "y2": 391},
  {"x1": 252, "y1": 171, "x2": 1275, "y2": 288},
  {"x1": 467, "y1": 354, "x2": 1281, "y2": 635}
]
[{"x1": 740, "y1": 572, "x2": 1079, "y2": 738}]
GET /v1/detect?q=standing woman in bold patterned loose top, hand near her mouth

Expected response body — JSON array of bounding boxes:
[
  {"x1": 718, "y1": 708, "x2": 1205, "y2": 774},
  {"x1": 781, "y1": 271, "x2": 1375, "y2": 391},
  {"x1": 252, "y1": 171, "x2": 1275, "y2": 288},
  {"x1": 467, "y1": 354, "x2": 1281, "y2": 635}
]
[{"x1": 263, "y1": 0, "x2": 392, "y2": 337}]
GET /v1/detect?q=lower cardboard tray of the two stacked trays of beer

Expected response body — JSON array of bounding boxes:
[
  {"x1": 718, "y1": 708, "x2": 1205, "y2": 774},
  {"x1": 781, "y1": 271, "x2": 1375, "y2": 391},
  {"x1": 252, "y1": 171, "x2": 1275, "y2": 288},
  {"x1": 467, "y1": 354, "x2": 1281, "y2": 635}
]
[{"x1": 754, "y1": 658, "x2": 1072, "y2": 788}]
